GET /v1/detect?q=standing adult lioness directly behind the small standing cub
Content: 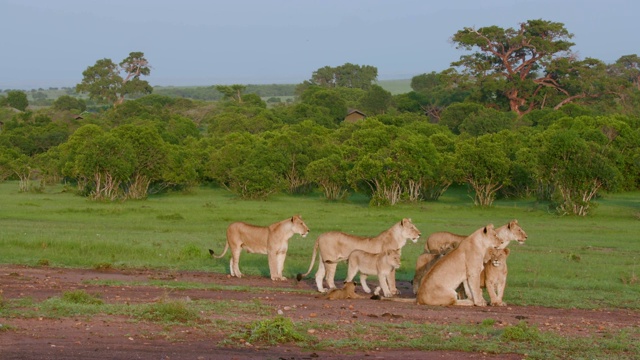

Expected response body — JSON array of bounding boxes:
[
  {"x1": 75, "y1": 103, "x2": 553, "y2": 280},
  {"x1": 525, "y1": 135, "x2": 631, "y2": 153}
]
[{"x1": 298, "y1": 218, "x2": 420, "y2": 294}]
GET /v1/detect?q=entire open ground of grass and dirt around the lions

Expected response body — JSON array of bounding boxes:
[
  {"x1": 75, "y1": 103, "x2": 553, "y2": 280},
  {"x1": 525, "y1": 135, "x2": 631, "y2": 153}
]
[{"x1": 0, "y1": 182, "x2": 640, "y2": 359}]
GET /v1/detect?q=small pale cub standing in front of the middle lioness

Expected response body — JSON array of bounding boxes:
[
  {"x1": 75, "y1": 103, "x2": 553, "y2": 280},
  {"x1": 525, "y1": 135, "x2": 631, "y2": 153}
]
[{"x1": 344, "y1": 249, "x2": 400, "y2": 297}]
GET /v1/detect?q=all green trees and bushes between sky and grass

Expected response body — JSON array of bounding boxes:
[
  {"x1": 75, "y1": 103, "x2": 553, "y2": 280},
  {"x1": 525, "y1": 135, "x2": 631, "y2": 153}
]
[{"x1": 0, "y1": 20, "x2": 640, "y2": 216}]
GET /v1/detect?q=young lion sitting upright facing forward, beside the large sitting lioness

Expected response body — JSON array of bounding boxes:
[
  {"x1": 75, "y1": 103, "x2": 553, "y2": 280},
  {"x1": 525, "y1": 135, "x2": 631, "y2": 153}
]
[{"x1": 480, "y1": 248, "x2": 509, "y2": 306}]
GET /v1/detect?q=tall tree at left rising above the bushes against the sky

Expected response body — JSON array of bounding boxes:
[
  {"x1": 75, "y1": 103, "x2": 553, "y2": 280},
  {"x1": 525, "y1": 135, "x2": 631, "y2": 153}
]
[{"x1": 76, "y1": 52, "x2": 153, "y2": 106}]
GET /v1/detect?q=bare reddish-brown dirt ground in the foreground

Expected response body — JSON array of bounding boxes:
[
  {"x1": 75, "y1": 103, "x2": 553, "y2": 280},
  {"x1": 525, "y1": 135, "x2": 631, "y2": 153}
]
[{"x1": 0, "y1": 265, "x2": 640, "y2": 360}]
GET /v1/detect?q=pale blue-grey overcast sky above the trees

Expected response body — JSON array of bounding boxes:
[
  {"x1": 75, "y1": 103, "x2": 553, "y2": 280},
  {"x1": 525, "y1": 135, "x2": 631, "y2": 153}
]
[{"x1": 0, "y1": 0, "x2": 640, "y2": 90}]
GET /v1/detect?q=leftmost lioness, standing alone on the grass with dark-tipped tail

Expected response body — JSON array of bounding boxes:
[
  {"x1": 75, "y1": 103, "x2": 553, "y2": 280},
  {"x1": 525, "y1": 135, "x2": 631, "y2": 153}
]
[{"x1": 209, "y1": 215, "x2": 309, "y2": 280}]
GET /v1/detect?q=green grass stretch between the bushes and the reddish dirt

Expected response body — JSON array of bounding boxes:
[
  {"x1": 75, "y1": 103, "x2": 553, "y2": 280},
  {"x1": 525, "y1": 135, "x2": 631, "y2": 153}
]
[{"x1": 0, "y1": 182, "x2": 640, "y2": 310}]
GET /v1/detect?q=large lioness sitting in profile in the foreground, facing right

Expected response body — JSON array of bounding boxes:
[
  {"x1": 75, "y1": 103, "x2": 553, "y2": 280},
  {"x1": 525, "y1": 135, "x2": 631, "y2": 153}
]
[{"x1": 416, "y1": 224, "x2": 505, "y2": 306}]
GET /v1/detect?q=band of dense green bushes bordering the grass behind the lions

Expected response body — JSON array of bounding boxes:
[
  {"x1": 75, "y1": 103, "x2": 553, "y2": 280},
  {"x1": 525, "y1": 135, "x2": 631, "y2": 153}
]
[{"x1": 0, "y1": 86, "x2": 640, "y2": 215}]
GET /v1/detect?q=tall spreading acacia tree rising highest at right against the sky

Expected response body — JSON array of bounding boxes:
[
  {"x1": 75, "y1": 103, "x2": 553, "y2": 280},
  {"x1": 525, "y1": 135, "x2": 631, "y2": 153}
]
[{"x1": 451, "y1": 20, "x2": 605, "y2": 116}]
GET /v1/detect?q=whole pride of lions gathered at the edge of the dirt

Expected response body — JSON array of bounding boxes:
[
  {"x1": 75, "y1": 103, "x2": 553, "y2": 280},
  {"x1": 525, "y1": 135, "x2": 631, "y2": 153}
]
[{"x1": 209, "y1": 215, "x2": 527, "y2": 306}]
